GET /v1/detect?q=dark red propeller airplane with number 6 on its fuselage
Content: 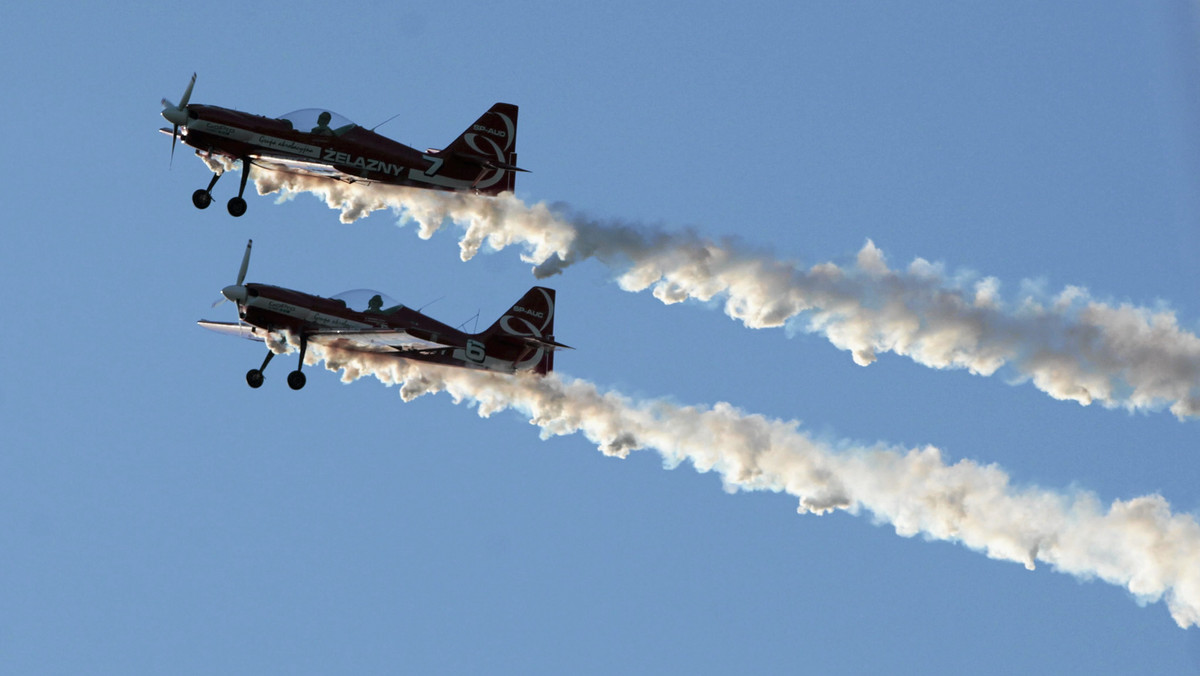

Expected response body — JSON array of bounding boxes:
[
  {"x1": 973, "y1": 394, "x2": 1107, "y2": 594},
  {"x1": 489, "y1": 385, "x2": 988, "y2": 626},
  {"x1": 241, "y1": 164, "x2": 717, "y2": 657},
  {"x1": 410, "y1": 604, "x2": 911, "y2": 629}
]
[{"x1": 197, "y1": 240, "x2": 572, "y2": 390}]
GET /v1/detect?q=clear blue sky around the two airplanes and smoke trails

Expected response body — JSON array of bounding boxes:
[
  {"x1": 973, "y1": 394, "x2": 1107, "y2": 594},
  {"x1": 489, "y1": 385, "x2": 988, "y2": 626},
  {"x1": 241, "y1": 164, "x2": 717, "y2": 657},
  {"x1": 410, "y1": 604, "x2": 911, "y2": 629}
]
[{"x1": 0, "y1": 1, "x2": 1200, "y2": 674}]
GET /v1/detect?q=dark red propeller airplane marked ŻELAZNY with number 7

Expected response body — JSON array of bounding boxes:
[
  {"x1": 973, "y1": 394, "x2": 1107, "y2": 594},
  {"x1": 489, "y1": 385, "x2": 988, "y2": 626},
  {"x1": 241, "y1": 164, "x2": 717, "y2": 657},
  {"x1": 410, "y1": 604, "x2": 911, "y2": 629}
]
[{"x1": 160, "y1": 73, "x2": 526, "y2": 216}]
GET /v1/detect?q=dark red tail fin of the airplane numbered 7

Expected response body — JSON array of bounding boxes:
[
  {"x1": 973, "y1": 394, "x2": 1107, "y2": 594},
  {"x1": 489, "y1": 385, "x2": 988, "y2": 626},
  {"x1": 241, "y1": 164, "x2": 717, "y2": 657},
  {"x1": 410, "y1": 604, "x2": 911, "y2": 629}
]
[{"x1": 438, "y1": 103, "x2": 524, "y2": 195}]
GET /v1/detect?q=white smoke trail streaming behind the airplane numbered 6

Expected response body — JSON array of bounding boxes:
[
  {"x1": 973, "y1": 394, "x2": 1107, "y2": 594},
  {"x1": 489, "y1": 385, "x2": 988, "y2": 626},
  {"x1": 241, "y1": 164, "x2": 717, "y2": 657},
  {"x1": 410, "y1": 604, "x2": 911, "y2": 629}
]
[{"x1": 300, "y1": 346, "x2": 1200, "y2": 628}]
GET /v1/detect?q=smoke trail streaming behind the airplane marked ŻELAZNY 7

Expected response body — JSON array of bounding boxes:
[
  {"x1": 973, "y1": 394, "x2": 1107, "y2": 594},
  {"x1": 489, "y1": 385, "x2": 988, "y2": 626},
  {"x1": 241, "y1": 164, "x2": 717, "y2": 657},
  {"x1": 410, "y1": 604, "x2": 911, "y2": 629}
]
[{"x1": 256, "y1": 172, "x2": 1200, "y2": 419}]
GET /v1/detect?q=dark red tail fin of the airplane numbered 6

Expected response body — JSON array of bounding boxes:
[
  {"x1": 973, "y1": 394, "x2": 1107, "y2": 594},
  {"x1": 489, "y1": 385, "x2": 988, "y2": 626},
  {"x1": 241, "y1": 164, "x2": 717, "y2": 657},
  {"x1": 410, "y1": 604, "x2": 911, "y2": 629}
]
[{"x1": 479, "y1": 287, "x2": 570, "y2": 376}]
